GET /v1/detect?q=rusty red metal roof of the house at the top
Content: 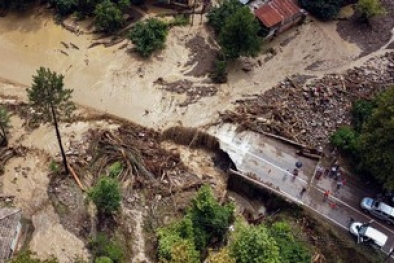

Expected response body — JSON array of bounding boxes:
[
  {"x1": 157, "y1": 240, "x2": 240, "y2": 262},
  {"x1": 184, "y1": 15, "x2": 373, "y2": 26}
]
[{"x1": 254, "y1": 0, "x2": 301, "y2": 28}]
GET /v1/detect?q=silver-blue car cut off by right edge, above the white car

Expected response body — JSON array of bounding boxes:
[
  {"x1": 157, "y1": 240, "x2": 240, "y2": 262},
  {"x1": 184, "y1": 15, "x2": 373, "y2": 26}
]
[{"x1": 360, "y1": 197, "x2": 394, "y2": 224}]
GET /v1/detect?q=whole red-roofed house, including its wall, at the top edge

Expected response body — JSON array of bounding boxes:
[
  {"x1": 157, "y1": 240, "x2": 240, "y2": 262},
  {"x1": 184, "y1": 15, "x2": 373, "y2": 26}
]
[{"x1": 254, "y1": 0, "x2": 307, "y2": 38}]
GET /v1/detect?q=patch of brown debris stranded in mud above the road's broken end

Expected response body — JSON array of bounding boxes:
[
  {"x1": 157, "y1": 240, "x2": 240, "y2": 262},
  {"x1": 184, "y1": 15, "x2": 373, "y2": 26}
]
[{"x1": 155, "y1": 78, "x2": 218, "y2": 107}]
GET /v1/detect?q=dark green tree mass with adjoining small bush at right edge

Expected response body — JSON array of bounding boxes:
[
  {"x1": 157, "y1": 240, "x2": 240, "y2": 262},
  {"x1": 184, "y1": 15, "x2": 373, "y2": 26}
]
[{"x1": 331, "y1": 87, "x2": 394, "y2": 190}]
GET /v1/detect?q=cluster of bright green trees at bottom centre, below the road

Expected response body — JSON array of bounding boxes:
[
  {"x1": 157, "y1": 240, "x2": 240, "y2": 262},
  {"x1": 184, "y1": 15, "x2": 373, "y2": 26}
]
[{"x1": 157, "y1": 186, "x2": 311, "y2": 263}]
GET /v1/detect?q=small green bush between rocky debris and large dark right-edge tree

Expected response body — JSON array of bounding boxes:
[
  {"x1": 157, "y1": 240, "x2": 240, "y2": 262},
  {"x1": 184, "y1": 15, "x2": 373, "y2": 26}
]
[{"x1": 330, "y1": 126, "x2": 358, "y2": 155}]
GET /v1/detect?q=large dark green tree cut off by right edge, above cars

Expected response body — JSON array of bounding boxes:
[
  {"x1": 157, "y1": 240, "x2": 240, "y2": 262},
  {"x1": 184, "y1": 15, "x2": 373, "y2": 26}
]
[{"x1": 359, "y1": 87, "x2": 394, "y2": 189}]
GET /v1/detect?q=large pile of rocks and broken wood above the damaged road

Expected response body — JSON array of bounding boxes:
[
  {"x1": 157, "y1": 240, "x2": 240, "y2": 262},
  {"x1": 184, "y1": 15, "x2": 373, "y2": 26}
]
[{"x1": 220, "y1": 52, "x2": 394, "y2": 149}]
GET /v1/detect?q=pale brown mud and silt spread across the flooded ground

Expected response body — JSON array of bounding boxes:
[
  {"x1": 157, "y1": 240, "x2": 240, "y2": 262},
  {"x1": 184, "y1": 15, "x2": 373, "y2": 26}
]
[{"x1": 0, "y1": 2, "x2": 387, "y2": 263}]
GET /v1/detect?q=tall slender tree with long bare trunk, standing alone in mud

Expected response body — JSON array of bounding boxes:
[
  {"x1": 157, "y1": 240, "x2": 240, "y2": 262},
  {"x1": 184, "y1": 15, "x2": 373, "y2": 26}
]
[{"x1": 26, "y1": 67, "x2": 75, "y2": 174}]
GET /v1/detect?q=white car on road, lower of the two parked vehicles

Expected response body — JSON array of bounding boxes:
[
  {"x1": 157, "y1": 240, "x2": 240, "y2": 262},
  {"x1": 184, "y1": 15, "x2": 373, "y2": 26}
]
[{"x1": 349, "y1": 222, "x2": 388, "y2": 249}]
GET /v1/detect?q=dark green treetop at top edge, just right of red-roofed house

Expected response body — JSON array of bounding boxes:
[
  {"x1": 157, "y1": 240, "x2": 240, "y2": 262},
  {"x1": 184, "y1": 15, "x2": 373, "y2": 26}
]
[{"x1": 300, "y1": 0, "x2": 343, "y2": 20}]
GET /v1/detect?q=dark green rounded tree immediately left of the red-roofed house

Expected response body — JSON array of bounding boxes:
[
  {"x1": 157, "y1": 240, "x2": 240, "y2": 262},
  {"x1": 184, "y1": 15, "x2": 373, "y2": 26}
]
[{"x1": 219, "y1": 6, "x2": 261, "y2": 60}]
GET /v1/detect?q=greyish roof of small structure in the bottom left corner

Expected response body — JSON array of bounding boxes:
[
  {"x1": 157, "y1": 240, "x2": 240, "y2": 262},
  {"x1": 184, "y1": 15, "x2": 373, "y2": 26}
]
[{"x1": 0, "y1": 207, "x2": 22, "y2": 263}]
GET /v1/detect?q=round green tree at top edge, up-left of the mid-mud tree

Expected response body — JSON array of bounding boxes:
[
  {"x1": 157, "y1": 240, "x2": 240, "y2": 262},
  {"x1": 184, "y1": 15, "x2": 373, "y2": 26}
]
[{"x1": 94, "y1": 0, "x2": 124, "y2": 33}]
